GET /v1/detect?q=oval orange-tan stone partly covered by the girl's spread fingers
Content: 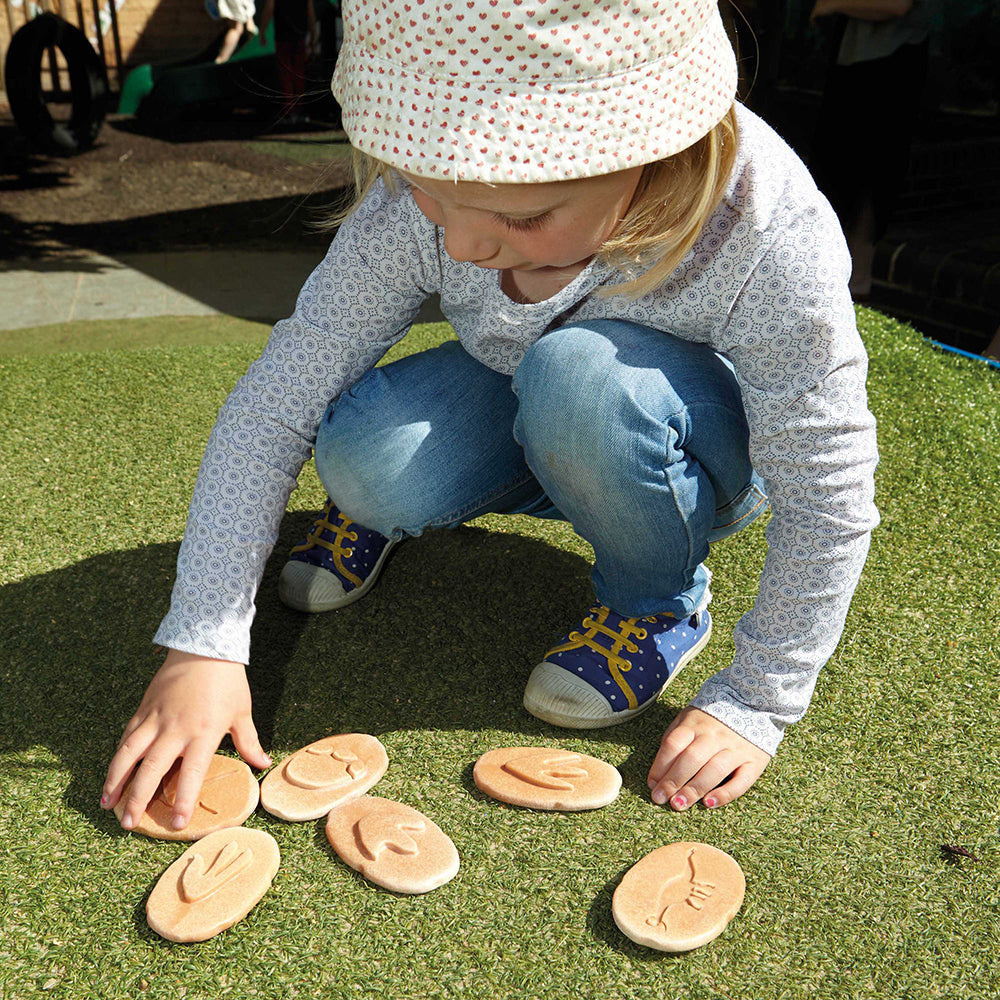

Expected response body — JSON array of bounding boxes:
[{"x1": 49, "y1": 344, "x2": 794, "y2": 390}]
[{"x1": 115, "y1": 753, "x2": 260, "y2": 840}]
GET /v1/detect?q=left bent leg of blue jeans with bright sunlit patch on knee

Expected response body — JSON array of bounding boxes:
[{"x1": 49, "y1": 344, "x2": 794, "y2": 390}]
[{"x1": 316, "y1": 341, "x2": 536, "y2": 537}]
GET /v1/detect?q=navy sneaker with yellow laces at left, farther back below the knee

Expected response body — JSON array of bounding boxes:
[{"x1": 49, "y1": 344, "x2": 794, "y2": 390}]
[{"x1": 278, "y1": 500, "x2": 397, "y2": 612}]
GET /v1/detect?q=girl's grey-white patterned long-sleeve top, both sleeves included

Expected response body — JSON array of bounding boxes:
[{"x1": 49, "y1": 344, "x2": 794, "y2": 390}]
[{"x1": 155, "y1": 108, "x2": 878, "y2": 753}]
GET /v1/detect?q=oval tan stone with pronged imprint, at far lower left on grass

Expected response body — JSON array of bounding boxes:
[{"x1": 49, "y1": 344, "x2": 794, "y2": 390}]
[{"x1": 146, "y1": 826, "x2": 281, "y2": 941}]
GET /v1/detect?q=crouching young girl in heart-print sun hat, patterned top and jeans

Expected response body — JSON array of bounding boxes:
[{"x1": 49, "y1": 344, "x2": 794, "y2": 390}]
[{"x1": 102, "y1": 0, "x2": 877, "y2": 828}]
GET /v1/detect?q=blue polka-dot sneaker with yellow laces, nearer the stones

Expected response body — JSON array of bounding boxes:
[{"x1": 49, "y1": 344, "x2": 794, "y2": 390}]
[{"x1": 524, "y1": 604, "x2": 712, "y2": 729}]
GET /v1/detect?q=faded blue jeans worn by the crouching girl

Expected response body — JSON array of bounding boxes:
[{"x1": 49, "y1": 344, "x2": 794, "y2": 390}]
[{"x1": 316, "y1": 320, "x2": 767, "y2": 617}]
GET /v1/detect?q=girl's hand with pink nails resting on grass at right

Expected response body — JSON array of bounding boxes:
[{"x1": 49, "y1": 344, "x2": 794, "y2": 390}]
[{"x1": 647, "y1": 705, "x2": 771, "y2": 810}]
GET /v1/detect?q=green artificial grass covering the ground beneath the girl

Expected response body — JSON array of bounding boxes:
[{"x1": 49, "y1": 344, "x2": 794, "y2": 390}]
[{"x1": 0, "y1": 310, "x2": 1000, "y2": 1000}]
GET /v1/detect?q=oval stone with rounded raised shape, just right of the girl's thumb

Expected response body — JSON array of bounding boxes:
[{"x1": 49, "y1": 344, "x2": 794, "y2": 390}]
[{"x1": 260, "y1": 733, "x2": 389, "y2": 822}]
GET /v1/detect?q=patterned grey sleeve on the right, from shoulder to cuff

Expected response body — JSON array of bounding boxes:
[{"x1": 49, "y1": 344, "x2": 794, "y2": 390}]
[{"x1": 693, "y1": 204, "x2": 878, "y2": 754}]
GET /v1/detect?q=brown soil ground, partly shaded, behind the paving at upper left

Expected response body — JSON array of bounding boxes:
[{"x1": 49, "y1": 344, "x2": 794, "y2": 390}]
[{"x1": 0, "y1": 112, "x2": 349, "y2": 260}]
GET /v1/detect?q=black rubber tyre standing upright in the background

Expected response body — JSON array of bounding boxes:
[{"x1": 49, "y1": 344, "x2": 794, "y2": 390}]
[{"x1": 4, "y1": 14, "x2": 110, "y2": 156}]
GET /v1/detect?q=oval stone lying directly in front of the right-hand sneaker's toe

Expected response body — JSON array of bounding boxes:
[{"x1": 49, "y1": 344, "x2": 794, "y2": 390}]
[{"x1": 472, "y1": 747, "x2": 622, "y2": 812}]
